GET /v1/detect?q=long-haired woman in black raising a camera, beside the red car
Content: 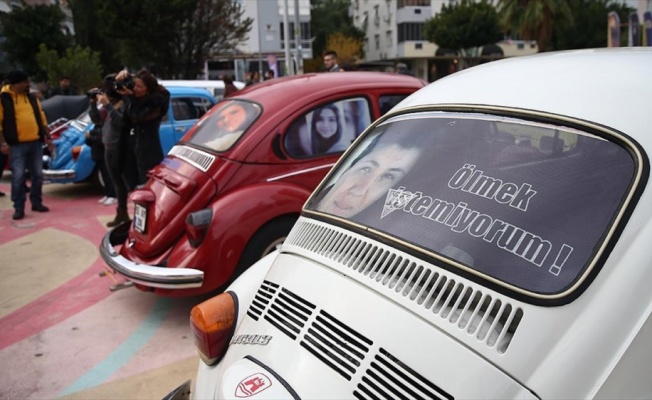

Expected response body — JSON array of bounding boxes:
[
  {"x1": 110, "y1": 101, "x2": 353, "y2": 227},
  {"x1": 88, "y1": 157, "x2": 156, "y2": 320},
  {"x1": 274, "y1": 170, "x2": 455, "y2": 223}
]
[{"x1": 116, "y1": 69, "x2": 170, "y2": 186}]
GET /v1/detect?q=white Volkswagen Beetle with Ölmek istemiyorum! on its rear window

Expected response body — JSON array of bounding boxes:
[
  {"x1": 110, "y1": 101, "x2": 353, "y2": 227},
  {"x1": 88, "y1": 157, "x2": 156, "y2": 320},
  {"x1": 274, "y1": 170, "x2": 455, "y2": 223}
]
[{"x1": 170, "y1": 48, "x2": 652, "y2": 399}]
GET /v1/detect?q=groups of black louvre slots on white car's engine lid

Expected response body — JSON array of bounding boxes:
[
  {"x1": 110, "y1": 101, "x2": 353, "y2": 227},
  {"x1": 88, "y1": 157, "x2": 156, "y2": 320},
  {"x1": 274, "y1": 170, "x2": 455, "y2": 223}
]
[{"x1": 247, "y1": 280, "x2": 453, "y2": 400}]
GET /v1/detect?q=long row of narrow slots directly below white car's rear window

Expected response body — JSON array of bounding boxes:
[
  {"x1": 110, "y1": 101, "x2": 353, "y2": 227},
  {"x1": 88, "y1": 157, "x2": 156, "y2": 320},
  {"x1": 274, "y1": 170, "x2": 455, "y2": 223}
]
[{"x1": 281, "y1": 219, "x2": 523, "y2": 354}]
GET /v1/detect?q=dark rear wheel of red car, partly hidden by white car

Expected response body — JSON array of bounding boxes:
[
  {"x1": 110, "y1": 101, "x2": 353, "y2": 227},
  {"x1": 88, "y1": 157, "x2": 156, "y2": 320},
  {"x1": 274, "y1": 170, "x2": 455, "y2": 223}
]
[{"x1": 231, "y1": 217, "x2": 297, "y2": 281}]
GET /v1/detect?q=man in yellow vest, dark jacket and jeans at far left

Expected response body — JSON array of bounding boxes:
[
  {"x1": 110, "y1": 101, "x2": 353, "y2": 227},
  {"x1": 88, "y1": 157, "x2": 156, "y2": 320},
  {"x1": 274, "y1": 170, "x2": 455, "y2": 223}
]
[{"x1": 0, "y1": 71, "x2": 52, "y2": 220}]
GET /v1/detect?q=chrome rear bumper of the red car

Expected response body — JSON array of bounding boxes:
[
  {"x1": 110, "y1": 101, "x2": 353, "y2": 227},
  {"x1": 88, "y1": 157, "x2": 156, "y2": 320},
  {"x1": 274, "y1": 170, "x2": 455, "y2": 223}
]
[{"x1": 100, "y1": 223, "x2": 204, "y2": 289}]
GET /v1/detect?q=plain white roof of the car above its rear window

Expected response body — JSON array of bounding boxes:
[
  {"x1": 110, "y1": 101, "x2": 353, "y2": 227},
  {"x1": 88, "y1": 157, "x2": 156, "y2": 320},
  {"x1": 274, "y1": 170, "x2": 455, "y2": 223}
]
[{"x1": 393, "y1": 47, "x2": 652, "y2": 147}]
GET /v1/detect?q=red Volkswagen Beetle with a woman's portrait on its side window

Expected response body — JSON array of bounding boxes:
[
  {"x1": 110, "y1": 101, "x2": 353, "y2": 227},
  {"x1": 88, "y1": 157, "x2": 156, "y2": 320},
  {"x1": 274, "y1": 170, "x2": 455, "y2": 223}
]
[{"x1": 95, "y1": 72, "x2": 426, "y2": 296}]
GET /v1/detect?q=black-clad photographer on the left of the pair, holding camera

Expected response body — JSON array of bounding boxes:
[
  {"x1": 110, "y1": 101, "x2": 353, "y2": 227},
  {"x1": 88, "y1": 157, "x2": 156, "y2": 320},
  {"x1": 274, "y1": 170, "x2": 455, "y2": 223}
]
[{"x1": 87, "y1": 74, "x2": 129, "y2": 228}]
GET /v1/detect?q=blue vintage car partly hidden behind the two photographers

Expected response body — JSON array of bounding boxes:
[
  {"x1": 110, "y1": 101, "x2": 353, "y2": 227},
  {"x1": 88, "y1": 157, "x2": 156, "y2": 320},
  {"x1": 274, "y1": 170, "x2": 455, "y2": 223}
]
[{"x1": 43, "y1": 86, "x2": 216, "y2": 186}]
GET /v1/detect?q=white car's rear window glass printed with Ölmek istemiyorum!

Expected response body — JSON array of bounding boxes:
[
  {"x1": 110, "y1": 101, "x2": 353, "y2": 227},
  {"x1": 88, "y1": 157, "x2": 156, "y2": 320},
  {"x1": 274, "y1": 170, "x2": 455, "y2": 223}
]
[{"x1": 306, "y1": 112, "x2": 640, "y2": 298}]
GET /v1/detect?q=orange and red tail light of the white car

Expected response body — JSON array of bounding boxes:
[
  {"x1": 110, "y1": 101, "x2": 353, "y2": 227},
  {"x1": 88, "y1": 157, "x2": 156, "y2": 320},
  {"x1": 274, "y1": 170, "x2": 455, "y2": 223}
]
[{"x1": 190, "y1": 292, "x2": 238, "y2": 365}]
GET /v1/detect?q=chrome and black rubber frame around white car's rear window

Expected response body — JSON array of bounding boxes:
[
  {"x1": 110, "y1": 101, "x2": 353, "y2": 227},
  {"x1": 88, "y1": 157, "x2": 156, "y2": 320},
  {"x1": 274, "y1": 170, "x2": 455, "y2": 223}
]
[{"x1": 302, "y1": 104, "x2": 650, "y2": 306}]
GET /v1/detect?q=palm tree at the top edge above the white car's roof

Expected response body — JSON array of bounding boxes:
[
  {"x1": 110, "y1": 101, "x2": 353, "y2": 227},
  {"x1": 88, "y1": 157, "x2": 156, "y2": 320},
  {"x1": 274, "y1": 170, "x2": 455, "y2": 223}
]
[{"x1": 498, "y1": 0, "x2": 573, "y2": 51}]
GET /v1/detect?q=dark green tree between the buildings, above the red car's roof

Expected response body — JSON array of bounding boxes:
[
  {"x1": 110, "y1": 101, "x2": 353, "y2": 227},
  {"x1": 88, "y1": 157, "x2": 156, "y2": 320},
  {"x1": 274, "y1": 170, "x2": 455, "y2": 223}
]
[{"x1": 310, "y1": 0, "x2": 365, "y2": 61}]
